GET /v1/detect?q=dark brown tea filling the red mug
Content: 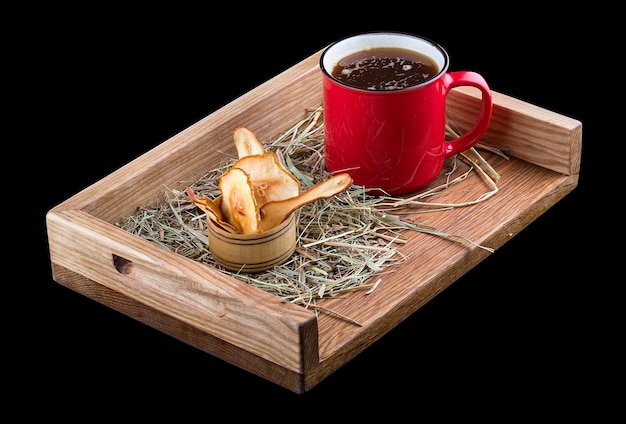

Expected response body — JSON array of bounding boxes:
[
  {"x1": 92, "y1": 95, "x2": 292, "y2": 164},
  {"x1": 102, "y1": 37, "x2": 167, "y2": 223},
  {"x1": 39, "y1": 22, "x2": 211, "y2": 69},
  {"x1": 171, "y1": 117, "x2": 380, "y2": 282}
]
[{"x1": 332, "y1": 47, "x2": 439, "y2": 91}]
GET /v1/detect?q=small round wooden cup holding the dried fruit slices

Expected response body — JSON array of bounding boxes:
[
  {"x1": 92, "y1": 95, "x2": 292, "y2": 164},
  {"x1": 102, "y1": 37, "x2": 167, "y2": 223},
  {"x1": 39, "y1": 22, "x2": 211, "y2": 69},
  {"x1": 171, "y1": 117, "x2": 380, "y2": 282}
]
[{"x1": 207, "y1": 203, "x2": 296, "y2": 273}]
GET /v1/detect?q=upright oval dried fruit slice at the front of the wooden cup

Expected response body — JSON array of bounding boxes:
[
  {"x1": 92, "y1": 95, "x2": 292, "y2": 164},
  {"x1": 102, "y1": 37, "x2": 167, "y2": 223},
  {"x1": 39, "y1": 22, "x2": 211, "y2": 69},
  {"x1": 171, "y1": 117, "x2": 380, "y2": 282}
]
[{"x1": 219, "y1": 168, "x2": 261, "y2": 234}]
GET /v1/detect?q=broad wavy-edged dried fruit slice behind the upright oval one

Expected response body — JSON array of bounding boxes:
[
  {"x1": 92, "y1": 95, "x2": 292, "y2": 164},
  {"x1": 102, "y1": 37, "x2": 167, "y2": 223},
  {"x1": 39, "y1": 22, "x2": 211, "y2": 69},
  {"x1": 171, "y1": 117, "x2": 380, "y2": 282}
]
[{"x1": 233, "y1": 151, "x2": 300, "y2": 208}]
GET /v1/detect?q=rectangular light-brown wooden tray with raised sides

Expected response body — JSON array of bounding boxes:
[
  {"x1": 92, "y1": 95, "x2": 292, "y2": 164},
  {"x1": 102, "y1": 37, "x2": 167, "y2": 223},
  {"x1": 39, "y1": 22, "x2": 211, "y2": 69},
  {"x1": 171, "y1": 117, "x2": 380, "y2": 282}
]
[{"x1": 46, "y1": 51, "x2": 582, "y2": 393}]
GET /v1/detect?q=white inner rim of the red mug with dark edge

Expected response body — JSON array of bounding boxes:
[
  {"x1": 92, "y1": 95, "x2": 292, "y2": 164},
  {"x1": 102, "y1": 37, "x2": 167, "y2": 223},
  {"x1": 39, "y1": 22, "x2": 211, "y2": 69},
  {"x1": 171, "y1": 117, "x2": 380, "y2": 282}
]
[{"x1": 320, "y1": 32, "x2": 450, "y2": 93}]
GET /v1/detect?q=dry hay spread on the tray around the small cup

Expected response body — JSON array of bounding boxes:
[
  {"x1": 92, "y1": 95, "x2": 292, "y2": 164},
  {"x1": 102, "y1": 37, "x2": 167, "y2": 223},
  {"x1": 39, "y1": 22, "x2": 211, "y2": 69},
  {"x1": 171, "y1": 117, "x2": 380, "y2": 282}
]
[{"x1": 118, "y1": 108, "x2": 504, "y2": 310}]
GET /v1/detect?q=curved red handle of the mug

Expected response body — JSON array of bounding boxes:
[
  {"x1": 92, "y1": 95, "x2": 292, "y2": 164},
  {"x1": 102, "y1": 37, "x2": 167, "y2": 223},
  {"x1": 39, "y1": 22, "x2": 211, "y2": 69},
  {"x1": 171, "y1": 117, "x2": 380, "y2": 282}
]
[{"x1": 444, "y1": 71, "x2": 493, "y2": 158}]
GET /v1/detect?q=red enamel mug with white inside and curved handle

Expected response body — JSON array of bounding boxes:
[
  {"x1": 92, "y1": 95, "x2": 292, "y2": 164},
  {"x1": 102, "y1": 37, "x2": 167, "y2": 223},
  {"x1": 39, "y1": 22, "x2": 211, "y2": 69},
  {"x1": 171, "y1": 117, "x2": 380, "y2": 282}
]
[{"x1": 320, "y1": 32, "x2": 493, "y2": 195}]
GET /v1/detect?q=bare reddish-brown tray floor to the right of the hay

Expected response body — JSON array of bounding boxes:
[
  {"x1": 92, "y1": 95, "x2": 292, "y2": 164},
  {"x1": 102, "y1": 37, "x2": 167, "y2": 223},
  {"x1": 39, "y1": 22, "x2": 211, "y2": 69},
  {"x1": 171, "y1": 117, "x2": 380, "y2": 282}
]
[{"x1": 310, "y1": 155, "x2": 578, "y2": 385}]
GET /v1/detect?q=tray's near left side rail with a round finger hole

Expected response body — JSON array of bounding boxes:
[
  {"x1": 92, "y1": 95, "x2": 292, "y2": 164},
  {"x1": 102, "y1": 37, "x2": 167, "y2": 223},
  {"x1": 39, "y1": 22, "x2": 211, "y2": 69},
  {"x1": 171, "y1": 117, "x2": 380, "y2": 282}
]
[{"x1": 46, "y1": 210, "x2": 319, "y2": 373}]
